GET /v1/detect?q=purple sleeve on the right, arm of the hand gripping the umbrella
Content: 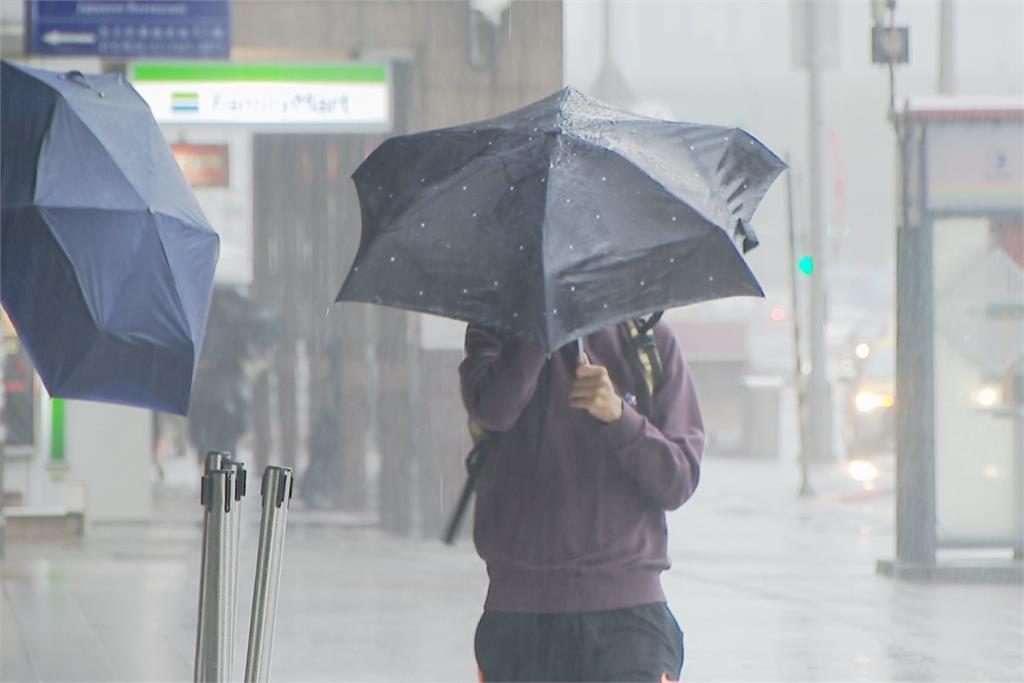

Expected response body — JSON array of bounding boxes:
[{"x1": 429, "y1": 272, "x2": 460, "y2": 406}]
[{"x1": 602, "y1": 326, "x2": 705, "y2": 510}]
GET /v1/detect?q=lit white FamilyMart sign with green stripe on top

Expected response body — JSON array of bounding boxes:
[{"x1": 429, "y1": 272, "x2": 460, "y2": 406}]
[{"x1": 129, "y1": 62, "x2": 391, "y2": 131}]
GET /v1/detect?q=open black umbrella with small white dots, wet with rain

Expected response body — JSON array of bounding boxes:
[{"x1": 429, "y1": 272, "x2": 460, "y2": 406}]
[{"x1": 338, "y1": 88, "x2": 785, "y2": 350}]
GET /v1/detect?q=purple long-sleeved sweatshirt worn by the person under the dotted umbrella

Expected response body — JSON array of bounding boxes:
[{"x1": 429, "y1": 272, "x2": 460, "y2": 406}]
[{"x1": 459, "y1": 325, "x2": 703, "y2": 612}]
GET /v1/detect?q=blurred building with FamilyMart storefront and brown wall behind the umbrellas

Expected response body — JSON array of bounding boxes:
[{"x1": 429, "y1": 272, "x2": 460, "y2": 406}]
[{"x1": 0, "y1": 0, "x2": 562, "y2": 535}]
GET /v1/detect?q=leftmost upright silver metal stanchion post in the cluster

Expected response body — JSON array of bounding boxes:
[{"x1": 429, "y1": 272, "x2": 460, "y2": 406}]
[{"x1": 196, "y1": 469, "x2": 236, "y2": 683}]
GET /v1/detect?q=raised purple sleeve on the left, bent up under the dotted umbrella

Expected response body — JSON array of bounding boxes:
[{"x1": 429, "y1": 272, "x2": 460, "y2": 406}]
[{"x1": 459, "y1": 326, "x2": 548, "y2": 432}]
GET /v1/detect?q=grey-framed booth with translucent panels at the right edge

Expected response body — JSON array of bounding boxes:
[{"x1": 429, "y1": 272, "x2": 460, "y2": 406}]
[{"x1": 878, "y1": 97, "x2": 1024, "y2": 581}]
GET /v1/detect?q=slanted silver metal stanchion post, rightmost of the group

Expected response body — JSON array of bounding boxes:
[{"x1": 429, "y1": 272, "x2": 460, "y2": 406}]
[{"x1": 246, "y1": 466, "x2": 295, "y2": 683}]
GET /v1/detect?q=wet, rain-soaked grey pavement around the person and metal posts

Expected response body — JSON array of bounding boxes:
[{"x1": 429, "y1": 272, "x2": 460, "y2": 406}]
[{"x1": 0, "y1": 457, "x2": 1024, "y2": 683}]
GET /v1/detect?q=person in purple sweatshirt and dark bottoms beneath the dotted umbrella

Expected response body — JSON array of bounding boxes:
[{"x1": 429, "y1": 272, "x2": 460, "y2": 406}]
[{"x1": 460, "y1": 315, "x2": 703, "y2": 682}]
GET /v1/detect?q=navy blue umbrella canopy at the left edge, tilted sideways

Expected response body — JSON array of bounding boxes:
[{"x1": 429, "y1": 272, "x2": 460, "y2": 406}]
[{"x1": 0, "y1": 61, "x2": 219, "y2": 414}]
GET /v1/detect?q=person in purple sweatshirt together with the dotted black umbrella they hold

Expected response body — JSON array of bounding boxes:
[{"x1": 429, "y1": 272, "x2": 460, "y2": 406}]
[{"x1": 337, "y1": 88, "x2": 785, "y2": 681}]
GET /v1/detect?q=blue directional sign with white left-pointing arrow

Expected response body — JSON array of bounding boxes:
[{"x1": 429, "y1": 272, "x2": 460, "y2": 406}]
[{"x1": 28, "y1": 0, "x2": 231, "y2": 58}]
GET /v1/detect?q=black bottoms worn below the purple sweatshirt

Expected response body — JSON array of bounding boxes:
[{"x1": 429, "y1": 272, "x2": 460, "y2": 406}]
[{"x1": 475, "y1": 602, "x2": 683, "y2": 683}]
